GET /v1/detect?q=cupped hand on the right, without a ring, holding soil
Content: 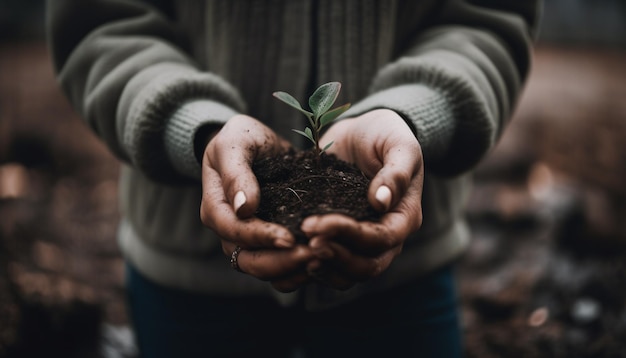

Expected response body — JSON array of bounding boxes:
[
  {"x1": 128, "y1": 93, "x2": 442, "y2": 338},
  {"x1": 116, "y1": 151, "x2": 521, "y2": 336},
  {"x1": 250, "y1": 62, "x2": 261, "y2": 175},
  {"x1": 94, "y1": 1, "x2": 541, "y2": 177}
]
[{"x1": 302, "y1": 109, "x2": 424, "y2": 289}]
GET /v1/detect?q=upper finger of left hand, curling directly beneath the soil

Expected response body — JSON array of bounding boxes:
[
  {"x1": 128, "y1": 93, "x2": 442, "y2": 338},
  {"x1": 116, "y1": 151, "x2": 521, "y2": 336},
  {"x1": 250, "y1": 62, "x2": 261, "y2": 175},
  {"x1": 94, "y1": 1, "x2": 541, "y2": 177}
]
[{"x1": 200, "y1": 166, "x2": 295, "y2": 248}]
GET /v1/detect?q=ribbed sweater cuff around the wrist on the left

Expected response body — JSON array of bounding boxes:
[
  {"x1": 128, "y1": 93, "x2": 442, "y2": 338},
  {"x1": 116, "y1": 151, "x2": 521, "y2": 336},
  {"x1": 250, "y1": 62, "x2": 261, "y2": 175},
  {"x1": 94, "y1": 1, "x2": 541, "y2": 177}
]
[{"x1": 164, "y1": 100, "x2": 238, "y2": 178}]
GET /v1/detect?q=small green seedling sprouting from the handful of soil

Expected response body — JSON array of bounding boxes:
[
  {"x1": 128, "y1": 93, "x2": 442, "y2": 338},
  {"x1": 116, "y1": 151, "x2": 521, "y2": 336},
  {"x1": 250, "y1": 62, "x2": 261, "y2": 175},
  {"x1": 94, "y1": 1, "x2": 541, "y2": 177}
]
[{"x1": 273, "y1": 82, "x2": 350, "y2": 158}]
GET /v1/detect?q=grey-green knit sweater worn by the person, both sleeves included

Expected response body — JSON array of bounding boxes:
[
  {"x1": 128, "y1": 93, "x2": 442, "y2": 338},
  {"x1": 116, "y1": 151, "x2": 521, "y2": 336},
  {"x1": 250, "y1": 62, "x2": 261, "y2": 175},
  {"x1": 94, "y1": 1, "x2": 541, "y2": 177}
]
[{"x1": 47, "y1": 0, "x2": 539, "y2": 309}]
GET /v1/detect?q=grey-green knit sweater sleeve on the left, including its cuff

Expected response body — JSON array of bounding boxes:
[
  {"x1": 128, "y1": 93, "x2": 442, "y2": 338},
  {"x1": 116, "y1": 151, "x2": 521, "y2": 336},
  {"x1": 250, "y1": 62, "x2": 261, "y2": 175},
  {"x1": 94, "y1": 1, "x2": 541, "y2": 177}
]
[{"x1": 46, "y1": 0, "x2": 245, "y2": 183}]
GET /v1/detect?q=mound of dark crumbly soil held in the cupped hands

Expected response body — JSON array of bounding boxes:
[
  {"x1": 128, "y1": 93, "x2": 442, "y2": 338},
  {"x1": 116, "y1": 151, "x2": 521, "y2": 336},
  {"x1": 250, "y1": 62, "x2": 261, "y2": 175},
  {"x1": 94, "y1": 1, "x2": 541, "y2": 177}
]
[{"x1": 253, "y1": 150, "x2": 380, "y2": 241}]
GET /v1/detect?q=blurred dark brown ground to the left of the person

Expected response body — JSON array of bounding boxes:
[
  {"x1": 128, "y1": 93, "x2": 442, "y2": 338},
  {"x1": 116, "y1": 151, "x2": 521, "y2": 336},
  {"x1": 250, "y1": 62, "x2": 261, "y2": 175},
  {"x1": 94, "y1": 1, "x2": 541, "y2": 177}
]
[{"x1": 0, "y1": 43, "x2": 127, "y2": 357}]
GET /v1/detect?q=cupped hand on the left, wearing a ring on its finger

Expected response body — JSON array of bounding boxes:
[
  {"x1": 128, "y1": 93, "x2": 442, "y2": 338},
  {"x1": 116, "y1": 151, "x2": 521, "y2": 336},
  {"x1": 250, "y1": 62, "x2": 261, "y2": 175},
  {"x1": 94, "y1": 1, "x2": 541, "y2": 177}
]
[{"x1": 200, "y1": 115, "x2": 313, "y2": 292}]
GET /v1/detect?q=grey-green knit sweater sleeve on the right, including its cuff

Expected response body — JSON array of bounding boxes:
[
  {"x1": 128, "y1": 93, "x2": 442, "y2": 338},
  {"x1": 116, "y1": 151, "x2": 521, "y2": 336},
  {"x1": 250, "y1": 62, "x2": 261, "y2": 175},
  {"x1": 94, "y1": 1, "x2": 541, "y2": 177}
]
[{"x1": 344, "y1": 0, "x2": 540, "y2": 175}]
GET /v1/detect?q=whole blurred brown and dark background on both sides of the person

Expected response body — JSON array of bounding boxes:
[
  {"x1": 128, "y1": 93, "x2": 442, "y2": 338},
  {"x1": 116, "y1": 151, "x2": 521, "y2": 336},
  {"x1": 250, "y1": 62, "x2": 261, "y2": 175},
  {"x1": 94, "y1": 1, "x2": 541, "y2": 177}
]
[{"x1": 0, "y1": 0, "x2": 626, "y2": 358}]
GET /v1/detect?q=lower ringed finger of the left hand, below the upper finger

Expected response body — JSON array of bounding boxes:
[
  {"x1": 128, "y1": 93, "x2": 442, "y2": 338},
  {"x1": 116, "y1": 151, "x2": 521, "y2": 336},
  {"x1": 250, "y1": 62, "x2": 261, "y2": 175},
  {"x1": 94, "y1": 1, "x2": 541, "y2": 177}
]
[{"x1": 222, "y1": 241, "x2": 313, "y2": 281}]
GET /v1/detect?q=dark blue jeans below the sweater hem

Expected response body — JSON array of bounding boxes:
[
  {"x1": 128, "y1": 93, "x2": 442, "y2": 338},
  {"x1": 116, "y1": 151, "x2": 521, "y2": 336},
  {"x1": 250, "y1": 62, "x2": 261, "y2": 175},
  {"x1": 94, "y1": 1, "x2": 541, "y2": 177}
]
[{"x1": 127, "y1": 265, "x2": 462, "y2": 358}]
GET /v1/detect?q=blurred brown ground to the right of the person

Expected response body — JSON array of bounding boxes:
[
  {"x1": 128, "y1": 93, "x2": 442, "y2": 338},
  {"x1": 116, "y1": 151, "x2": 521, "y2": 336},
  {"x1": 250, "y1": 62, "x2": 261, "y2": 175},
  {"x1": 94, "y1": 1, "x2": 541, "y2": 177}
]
[{"x1": 460, "y1": 45, "x2": 626, "y2": 358}]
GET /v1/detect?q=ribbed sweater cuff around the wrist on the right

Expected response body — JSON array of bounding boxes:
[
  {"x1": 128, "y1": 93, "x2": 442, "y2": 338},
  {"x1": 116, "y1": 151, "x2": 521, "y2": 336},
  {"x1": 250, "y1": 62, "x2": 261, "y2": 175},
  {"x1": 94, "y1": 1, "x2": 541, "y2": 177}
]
[{"x1": 342, "y1": 84, "x2": 455, "y2": 163}]
